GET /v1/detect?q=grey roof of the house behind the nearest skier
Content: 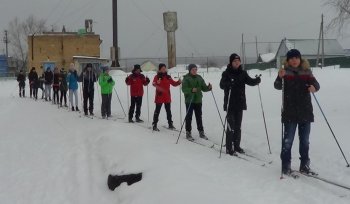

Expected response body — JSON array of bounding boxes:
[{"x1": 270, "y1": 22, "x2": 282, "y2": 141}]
[{"x1": 277, "y1": 39, "x2": 345, "y2": 56}]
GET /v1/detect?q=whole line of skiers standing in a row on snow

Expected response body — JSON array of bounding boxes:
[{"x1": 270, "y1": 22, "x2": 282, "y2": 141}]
[{"x1": 17, "y1": 49, "x2": 320, "y2": 174}]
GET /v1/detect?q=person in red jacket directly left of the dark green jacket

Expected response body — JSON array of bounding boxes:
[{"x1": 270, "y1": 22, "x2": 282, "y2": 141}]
[{"x1": 152, "y1": 63, "x2": 181, "y2": 131}]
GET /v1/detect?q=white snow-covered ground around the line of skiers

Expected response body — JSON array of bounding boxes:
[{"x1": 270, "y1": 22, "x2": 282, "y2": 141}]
[{"x1": 0, "y1": 67, "x2": 350, "y2": 204}]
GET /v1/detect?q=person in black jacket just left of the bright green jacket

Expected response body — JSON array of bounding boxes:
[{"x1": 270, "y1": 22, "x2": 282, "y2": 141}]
[{"x1": 80, "y1": 63, "x2": 96, "y2": 115}]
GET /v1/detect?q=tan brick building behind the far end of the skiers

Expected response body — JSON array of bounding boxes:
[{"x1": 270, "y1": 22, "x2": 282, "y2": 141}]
[{"x1": 28, "y1": 32, "x2": 101, "y2": 74}]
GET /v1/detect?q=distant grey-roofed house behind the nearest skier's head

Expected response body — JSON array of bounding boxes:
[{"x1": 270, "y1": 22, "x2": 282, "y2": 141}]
[{"x1": 276, "y1": 39, "x2": 346, "y2": 67}]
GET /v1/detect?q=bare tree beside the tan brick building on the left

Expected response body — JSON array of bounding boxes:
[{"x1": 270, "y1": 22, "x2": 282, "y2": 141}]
[{"x1": 8, "y1": 15, "x2": 46, "y2": 69}]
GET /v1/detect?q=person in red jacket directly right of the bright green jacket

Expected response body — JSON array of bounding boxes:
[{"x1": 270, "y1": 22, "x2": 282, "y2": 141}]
[{"x1": 125, "y1": 64, "x2": 150, "y2": 123}]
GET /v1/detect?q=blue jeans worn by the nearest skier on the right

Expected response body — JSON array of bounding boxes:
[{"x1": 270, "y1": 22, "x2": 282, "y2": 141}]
[{"x1": 281, "y1": 122, "x2": 311, "y2": 168}]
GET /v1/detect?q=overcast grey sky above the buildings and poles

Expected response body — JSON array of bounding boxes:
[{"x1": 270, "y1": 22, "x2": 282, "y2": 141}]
[{"x1": 0, "y1": 0, "x2": 350, "y2": 58}]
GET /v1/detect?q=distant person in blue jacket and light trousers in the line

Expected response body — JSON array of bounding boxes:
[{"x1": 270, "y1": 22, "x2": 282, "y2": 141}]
[{"x1": 67, "y1": 63, "x2": 79, "y2": 111}]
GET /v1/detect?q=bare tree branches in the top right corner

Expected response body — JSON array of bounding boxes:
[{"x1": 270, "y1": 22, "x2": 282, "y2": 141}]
[{"x1": 325, "y1": 0, "x2": 350, "y2": 33}]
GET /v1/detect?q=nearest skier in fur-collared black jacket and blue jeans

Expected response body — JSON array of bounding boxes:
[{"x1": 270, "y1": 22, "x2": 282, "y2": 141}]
[{"x1": 274, "y1": 49, "x2": 320, "y2": 174}]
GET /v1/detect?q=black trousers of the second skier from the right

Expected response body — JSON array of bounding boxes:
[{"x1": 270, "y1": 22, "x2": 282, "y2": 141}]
[{"x1": 226, "y1": 110, "x2": 243, "y2": 150}]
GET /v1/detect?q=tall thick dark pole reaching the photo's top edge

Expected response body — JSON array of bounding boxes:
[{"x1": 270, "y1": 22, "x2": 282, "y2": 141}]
[{"x1": 111, "y1": 0, "x2": 120, "y2": 67}]
